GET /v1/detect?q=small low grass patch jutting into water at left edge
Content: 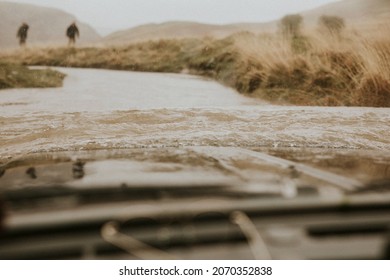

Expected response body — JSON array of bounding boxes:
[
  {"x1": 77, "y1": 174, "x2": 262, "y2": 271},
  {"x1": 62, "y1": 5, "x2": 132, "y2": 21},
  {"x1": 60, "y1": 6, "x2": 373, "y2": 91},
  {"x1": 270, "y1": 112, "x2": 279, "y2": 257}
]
[{"x1": 0, "y1": 62, "x2": 65, "y2": 89}]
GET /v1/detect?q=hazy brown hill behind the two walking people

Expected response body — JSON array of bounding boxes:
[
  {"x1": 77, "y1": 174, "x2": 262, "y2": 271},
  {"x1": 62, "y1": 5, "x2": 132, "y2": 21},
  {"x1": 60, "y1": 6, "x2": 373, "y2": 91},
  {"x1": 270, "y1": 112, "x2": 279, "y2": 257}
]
[{"x1": 0, "y1": 2, "x2": 101, "y2": 49}]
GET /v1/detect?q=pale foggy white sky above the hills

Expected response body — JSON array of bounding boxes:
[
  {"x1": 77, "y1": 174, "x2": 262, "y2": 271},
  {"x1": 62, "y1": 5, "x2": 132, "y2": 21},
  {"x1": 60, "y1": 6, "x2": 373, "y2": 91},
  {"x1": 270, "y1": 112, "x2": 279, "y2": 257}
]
[{"x1": 8, "y1": 0, "x2": 337, "y2": 35}]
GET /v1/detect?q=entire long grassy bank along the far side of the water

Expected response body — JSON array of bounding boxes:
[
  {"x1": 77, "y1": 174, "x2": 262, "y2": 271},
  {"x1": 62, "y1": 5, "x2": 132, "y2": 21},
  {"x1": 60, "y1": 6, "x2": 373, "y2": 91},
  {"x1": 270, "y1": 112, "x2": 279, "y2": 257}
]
[{"x1": 0, "y1": 22, "x2": 390, "y2": 107}]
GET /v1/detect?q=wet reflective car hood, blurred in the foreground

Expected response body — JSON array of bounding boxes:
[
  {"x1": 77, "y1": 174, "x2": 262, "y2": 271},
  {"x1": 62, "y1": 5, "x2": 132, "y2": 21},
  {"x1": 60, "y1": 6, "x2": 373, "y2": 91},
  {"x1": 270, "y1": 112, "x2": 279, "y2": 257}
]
[{"x1": 0, "y1": 147, "x2": 390, "y2": 259}]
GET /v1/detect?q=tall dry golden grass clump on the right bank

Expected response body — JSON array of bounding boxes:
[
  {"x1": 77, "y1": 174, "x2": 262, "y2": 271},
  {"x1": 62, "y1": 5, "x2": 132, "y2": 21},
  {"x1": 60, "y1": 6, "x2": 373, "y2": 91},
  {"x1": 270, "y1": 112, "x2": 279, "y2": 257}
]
[{"x1": 236, "y1": 23, "x2": 390, "y2": 107}]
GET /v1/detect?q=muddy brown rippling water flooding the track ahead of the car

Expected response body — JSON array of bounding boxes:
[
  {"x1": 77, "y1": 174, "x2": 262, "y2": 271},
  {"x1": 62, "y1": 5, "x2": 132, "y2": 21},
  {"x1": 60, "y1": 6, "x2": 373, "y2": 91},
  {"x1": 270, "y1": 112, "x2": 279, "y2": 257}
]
[{"x1": 0, "y1": 69, "x2": 390, "y2": 182}]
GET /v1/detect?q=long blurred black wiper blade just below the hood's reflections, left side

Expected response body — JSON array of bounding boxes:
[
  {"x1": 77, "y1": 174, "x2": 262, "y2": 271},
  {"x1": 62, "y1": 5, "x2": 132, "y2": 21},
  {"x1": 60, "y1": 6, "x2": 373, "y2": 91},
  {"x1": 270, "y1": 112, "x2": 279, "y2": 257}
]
[{"x1": 3, "y1": 184, "x2": 235, "y2": 208}]
